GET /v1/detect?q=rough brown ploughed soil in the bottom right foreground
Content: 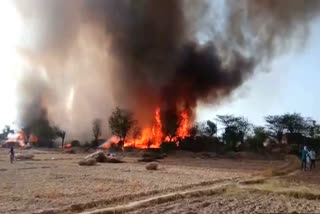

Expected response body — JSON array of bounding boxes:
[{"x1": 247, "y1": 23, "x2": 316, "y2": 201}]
[{"x1": 129, "y1": 193, "x2": 320, "y2": 214}]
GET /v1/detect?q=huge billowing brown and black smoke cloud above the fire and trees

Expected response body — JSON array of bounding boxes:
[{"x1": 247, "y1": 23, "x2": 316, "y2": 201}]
[{"x1": 11, "y1": 0, "x2": 320, "y2": 140}]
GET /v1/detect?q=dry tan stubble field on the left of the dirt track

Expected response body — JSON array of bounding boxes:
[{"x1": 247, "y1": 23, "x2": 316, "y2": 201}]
[{"x1": 0, "y1": 149, "x2": 288, "y2": 214}]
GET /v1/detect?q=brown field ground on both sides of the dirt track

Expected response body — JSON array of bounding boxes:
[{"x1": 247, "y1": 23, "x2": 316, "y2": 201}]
[{"x1": 0, "y1": 149, "x2": 320, "y2": 214}]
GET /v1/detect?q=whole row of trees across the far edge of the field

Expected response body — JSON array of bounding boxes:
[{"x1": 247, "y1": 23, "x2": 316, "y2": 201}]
[{"x1": 0, "y1": 107, "x2": 320, "y2": 151}]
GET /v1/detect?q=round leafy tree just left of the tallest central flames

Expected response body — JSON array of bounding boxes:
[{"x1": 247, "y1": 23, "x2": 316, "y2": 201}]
[{"x1": 109, "y1": 107, "x2": 136, "y2": 141}]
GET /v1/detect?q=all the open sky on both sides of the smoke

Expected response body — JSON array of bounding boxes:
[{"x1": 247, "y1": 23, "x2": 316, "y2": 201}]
[{"x1": 0, "y1": 0, "x2": 320, "y2": 129}]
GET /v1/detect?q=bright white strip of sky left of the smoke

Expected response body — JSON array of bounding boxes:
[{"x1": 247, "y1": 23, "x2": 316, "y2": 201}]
[{"x1": 0, "y1": 0, "x2": 21, "y2": 128}]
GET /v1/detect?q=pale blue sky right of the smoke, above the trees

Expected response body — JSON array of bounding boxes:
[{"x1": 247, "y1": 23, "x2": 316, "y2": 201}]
[{"x1": 197, "y1": 19, "x2": 320, "y2": 125}]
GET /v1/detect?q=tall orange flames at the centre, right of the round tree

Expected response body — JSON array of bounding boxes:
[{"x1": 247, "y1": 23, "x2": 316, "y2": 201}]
[{"x1": 122, "y1": 107, "x2": 190, "y2": 149}]
